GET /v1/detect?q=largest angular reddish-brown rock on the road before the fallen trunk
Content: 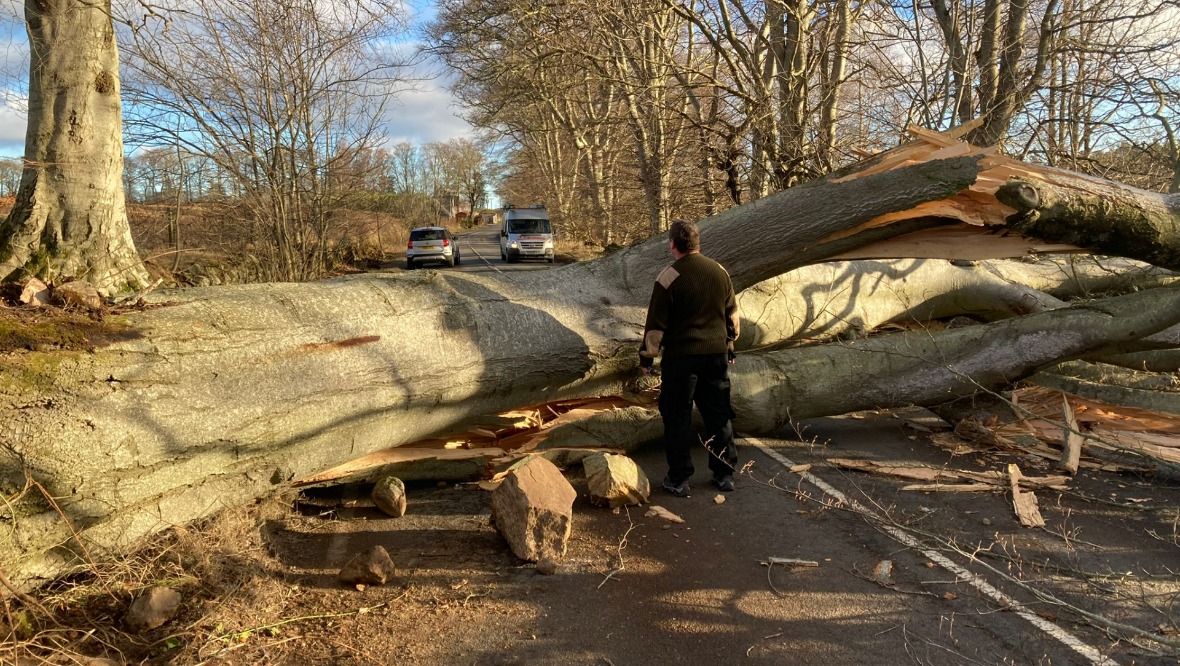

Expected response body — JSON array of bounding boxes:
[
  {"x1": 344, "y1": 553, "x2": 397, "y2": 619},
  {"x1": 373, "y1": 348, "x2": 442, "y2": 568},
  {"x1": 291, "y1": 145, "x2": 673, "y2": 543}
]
[{"x1": 492, "y1": 456, "x2": 577, "y2": 562}]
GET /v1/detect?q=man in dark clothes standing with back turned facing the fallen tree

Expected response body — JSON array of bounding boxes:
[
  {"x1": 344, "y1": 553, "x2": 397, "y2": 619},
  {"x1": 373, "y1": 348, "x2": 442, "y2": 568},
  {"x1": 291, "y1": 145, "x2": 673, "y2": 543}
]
[{"x1": 640, "y1": 220, "x2": 739, "y2": 497}]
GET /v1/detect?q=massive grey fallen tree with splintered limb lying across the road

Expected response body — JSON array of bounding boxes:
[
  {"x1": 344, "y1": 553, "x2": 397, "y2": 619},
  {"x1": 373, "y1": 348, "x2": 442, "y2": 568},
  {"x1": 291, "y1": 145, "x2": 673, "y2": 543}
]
[{"x1": 0, "y1": 129, "x2": 1180, "y2": 585}]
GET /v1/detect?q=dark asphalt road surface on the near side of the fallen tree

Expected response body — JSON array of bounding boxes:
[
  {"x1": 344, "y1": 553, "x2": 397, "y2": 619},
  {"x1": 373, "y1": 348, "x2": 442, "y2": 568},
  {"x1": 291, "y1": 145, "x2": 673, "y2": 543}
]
[{"x1": 278, "y1": 410, "x2": 1180, "y2": 666}]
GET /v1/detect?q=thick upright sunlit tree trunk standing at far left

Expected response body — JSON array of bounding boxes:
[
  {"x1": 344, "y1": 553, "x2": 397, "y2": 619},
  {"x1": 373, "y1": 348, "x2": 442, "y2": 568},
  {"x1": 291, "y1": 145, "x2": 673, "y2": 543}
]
[{"x1": 0, "y1": 0, "x2": 148, "y2": 293}]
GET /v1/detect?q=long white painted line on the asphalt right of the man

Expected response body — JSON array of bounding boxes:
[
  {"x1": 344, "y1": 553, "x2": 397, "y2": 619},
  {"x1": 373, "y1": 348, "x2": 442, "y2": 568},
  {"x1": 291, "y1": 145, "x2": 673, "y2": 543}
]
[{"x1": 741, "y1": 437, "x2": 1117, "y2": 666}]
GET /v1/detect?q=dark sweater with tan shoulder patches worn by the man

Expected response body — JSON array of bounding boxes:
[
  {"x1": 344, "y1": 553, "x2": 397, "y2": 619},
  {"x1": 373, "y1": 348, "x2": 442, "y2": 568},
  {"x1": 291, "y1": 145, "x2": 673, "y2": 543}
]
[{"x1": 640, "y1": 253, "x2": 739, "y2": 358}]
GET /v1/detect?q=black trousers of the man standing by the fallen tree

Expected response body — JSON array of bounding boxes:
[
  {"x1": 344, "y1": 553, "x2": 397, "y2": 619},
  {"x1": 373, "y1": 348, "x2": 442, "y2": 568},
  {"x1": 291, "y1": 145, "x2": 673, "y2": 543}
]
[{"x1": 660, "y1": 353, "x2": 738, "y2": 484}]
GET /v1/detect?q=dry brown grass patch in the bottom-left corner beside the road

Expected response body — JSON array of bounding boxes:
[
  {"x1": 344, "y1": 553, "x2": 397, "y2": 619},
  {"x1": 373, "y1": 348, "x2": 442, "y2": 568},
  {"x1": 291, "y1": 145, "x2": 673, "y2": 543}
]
[{"x1": 0, "y1": 491, "x2": 311, "y2": 664}]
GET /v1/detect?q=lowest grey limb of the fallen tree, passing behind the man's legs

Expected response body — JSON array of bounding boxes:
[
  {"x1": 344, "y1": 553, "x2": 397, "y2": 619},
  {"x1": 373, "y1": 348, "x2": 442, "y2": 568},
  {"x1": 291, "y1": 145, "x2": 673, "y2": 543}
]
[{"x1": 523, "y1": 286, "x2": 1180, "y2": 449}]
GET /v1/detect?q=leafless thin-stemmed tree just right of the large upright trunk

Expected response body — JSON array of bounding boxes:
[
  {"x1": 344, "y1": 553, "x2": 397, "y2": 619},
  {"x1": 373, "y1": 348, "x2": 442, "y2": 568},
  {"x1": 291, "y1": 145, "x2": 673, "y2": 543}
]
[{"x1": 119, "y1": 0, "x2": 407, "y2": 280}]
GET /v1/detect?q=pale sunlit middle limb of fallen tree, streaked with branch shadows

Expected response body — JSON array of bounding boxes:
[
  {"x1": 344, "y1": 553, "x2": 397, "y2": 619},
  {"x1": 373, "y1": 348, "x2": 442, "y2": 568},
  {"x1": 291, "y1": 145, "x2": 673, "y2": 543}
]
[{"x1": 738, "y1": 256, "x2": 1180, "y2": 349}]
